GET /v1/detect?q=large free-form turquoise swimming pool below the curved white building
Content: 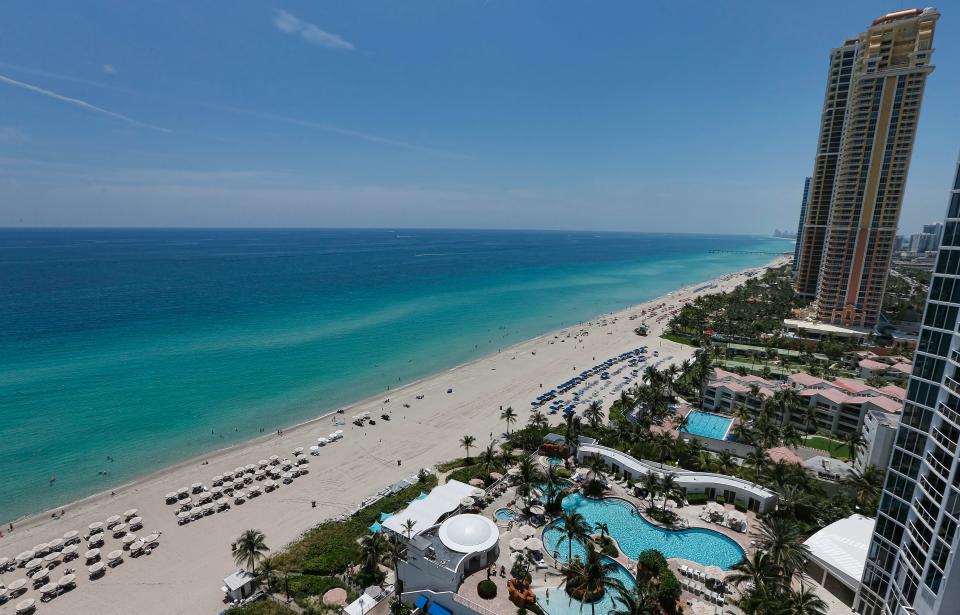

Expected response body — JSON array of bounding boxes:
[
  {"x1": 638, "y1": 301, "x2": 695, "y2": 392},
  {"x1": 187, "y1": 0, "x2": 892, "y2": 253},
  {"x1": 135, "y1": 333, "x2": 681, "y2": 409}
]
[{"x1": 543, "y1": 493, "x2": 744, "y2": 569}]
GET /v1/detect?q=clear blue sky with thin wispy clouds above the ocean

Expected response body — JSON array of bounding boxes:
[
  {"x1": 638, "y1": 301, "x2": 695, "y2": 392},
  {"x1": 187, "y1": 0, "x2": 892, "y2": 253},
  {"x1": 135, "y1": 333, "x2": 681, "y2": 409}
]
[{"x1": 0, "y1": 0, "x2": 960, "y2": 233}]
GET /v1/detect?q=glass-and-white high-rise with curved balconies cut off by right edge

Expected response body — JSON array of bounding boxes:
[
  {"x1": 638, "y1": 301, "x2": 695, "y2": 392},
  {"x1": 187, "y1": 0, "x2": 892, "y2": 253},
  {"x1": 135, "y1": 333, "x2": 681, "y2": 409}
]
[{"x1": 856, "y1": 162, "x2": 960, "y2": 615}]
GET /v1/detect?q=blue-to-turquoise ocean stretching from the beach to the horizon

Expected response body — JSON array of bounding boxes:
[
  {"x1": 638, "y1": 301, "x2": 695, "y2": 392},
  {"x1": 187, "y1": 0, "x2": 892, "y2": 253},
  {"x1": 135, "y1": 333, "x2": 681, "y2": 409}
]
[{"x1": 0, "y1": 229, "x2": 791, "y2": 521}]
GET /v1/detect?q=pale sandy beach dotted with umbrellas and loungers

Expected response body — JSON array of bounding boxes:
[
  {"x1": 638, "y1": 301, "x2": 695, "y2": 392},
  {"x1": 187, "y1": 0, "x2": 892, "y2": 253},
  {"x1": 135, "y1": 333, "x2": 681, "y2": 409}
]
[{"x1": 0, "y1": 257, "x2": 784, "y2": 615}]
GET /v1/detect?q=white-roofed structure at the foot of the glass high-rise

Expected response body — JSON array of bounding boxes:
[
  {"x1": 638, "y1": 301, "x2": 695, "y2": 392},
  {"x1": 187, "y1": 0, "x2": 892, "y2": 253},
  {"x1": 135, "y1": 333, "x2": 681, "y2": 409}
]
[{"x1": 804, "y1": 515, "x2": 875, "y2": 607}]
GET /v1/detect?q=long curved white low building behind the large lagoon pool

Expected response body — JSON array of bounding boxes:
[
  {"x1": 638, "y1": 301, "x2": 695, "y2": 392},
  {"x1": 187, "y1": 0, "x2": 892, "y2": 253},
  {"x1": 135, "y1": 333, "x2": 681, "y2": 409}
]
[{"x1": 577, "y1": 444, "x2": 777, "y2": 513}]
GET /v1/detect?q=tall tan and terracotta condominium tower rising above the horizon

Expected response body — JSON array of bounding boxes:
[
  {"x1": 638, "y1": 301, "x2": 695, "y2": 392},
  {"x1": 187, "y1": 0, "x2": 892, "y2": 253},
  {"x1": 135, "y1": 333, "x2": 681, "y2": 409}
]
[{"x1": 796, "y1": 9, "x2": 939, "y2": 326}]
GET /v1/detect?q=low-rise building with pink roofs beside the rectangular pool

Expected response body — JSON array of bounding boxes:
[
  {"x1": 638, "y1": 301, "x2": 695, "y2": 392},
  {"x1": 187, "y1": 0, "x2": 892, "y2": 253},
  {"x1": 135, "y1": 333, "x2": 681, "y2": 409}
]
[{"x1": 703, "y1": 369, "x2": 906, "y2": 436}]
